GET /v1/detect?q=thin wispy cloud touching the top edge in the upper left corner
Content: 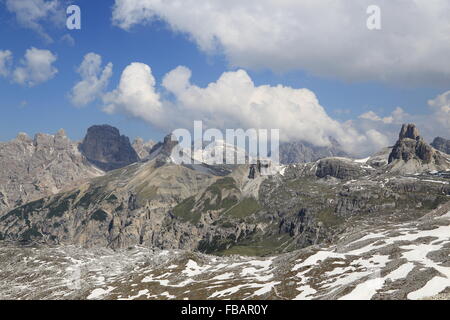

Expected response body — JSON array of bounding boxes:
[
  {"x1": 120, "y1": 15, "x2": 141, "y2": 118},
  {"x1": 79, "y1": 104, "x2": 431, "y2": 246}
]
[{"x1": 6, "y1": 0, "x2": 65, "y2": 42}]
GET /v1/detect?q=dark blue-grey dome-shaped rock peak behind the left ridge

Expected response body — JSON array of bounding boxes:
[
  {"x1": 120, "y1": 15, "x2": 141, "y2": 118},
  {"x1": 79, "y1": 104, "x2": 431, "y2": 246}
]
[{"x1": 80, "y1": 125, "x2": 139, "y2": 171}]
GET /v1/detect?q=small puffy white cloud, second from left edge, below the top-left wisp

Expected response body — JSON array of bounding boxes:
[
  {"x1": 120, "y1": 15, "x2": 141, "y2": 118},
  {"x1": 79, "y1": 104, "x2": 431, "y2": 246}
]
[{"x1": 12, "y1": 47, "x2": 58, "y2": 87}]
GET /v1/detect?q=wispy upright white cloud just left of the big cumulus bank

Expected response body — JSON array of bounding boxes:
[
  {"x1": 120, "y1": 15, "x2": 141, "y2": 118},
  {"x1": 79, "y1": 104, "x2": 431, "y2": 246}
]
[{"x1": 70, "y1": 52, "x2": 113, "y2": 106}]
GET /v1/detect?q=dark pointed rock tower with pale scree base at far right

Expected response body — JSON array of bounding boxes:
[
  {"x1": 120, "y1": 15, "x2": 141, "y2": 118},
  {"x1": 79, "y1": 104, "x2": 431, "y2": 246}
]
[{"x1": 389, "y1": 124, "x2": 450, "y2": 173}]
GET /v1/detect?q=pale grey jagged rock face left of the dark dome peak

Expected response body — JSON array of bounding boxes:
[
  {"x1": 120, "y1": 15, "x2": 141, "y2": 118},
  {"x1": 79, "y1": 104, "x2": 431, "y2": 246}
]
[{"x1": 0, "y1": 130, "x2": 103, "y2": 216}]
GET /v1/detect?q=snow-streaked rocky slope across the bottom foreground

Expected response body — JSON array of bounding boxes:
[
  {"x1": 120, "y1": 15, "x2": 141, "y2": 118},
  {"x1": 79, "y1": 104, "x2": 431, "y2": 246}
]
[{"x1": 0, "y1": 212, "x2": 450, "y2": 300}]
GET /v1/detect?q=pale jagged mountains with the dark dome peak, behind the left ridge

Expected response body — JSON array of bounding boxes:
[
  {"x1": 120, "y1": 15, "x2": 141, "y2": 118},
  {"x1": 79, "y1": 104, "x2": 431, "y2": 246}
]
[{"x1": 0, "y1": 125, "x2": 154, "y2": 216}]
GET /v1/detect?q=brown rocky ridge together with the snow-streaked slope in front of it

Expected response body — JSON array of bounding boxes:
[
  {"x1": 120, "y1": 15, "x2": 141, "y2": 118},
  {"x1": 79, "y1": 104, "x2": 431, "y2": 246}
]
[{"x1": 0, "y1": 124, "x2": 450, "y2": 299}]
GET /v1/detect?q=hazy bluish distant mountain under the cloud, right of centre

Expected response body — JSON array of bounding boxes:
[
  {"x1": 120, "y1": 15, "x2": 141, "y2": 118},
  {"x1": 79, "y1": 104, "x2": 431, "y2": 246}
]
[{"x1": 280, "y1": 138, "x2": 349, "y2": 164}]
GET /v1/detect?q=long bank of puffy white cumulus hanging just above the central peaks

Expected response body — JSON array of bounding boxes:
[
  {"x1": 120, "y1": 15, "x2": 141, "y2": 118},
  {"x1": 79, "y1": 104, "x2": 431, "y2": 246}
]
[{"x1": 103, "y1": 63, "x2": 387, "y2": 154}]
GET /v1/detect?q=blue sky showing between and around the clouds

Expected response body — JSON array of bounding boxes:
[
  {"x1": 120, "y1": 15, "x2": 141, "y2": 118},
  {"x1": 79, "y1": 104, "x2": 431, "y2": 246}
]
[{"x1": 0, "y1": 0, "x2": 450, "y2": 155}]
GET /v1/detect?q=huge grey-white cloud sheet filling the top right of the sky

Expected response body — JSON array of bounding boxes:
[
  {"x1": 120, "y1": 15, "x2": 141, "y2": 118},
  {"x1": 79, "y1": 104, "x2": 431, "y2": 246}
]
[{"x1": 113, "y1": 0, "x2": 450, "y2": 85}]
